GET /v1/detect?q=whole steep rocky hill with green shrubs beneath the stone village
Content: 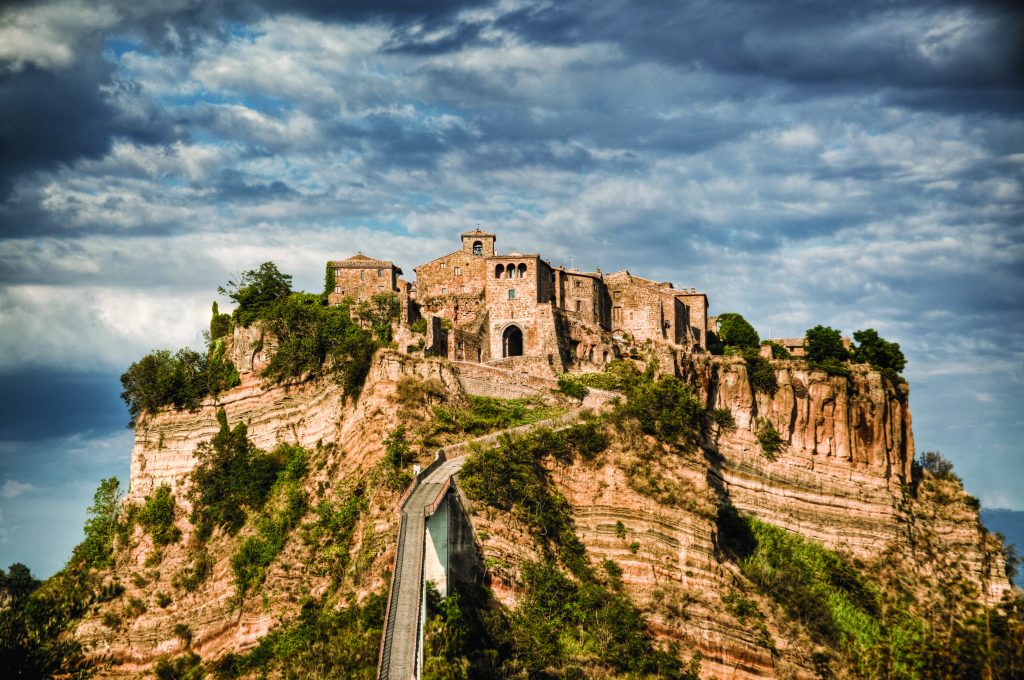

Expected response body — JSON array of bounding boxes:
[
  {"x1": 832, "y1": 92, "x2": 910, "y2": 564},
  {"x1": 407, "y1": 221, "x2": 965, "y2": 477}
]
[{"x1": 8, "y1": 270, "x2": 1024, "y2": 678}]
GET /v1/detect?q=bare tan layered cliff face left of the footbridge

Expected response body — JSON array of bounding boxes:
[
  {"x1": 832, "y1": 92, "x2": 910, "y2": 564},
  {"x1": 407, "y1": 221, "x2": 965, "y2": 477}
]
[{"x1": 76, "y1": 342, "x2": 461, "y2": 677}]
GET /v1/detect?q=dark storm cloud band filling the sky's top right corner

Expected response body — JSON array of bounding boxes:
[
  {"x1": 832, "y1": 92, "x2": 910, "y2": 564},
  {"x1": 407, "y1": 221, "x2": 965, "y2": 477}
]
[{"x1": 497, "y1": 0, "x2": 1024, "y2": 89}]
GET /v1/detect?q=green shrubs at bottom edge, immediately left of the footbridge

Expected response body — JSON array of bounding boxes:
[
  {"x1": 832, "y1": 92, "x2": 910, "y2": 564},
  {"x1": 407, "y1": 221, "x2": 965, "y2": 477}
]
[{"x1": 211, "y1": 593, "x2": 387, "y2": 680}]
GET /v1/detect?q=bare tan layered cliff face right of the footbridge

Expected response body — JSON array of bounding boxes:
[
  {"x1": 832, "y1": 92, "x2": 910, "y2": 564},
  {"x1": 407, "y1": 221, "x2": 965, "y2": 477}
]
[{"x1": 470, "y1": 357, "x2": 1011, "y2": 679}]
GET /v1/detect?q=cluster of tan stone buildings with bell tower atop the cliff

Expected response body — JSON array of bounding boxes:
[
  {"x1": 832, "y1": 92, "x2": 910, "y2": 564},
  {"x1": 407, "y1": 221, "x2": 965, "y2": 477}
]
[{"x1": 329, "y1": 228, "x2": 709, "y2": 375}]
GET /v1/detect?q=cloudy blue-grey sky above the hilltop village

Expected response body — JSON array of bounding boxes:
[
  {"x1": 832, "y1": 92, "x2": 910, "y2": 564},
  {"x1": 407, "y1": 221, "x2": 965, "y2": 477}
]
[{"x1": 0, "y1": 0, "x2": 1024, "y2": 577}]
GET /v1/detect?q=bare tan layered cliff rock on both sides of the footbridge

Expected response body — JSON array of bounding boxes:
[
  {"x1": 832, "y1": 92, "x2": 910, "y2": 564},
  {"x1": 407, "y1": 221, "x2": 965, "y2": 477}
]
[{"x1": 77, "y1": 330, "x2": 1011, "y2": 678}]
